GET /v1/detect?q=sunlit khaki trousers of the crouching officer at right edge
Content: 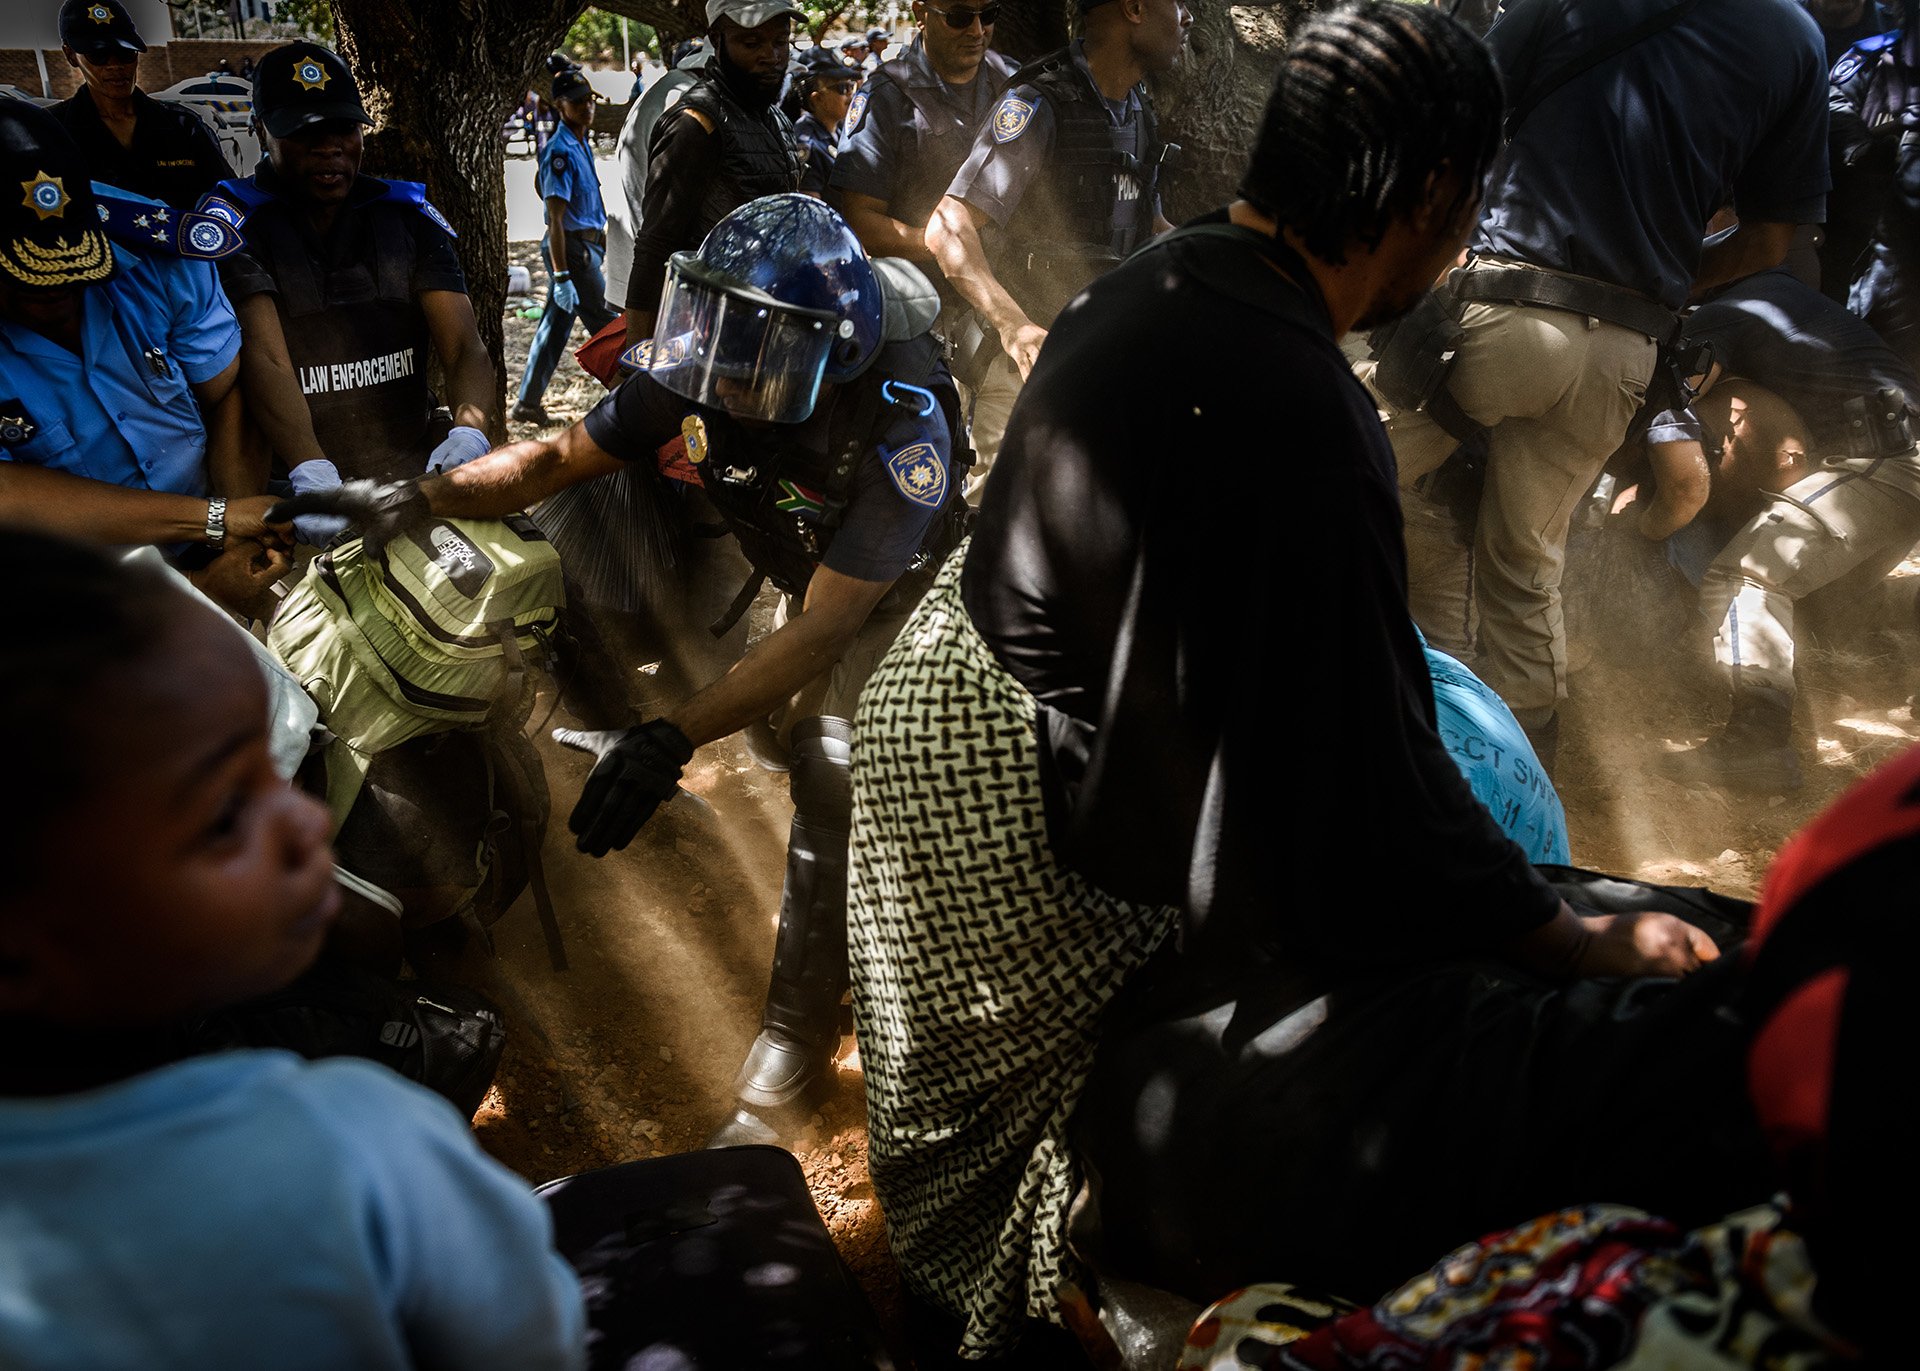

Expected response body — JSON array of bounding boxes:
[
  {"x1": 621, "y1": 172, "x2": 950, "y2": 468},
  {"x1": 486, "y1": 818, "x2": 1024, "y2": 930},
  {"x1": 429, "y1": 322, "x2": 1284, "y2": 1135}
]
[{"x1": 1699, "y1": 453, "x2": 1920, "y2": 695}]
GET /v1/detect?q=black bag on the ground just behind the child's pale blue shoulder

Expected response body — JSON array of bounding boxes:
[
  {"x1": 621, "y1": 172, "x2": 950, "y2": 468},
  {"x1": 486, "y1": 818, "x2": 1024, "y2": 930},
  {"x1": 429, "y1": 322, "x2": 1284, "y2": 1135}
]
[{"x1": 188, "y1": 958, "x2": 507, "y2": 1118}]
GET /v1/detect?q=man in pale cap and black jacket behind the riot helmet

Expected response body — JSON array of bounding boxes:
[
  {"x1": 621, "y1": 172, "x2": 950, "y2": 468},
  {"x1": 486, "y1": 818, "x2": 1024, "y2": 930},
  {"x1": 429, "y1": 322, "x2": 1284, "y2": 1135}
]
[{"x1": 626, "y1": 0, "x2": 806, "y2": 344}]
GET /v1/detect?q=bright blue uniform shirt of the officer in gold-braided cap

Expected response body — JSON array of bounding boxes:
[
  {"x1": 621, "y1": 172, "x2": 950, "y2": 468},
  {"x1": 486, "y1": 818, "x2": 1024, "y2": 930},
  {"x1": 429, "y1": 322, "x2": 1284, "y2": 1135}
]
[{"x1": 0, "y1": 231, "x2": 240, "y2": 495}]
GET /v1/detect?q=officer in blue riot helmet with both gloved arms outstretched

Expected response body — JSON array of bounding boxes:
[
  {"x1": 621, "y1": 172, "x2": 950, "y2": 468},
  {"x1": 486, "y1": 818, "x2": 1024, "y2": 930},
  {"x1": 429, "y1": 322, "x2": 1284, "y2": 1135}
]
[{"x1": 276, "y1": 194, "x2": 968, "y2": 1143}]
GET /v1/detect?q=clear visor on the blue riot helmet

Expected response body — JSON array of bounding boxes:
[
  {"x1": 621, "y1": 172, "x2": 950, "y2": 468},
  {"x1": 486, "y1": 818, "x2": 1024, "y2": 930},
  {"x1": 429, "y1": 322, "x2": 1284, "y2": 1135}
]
[{"x1": 647, "y1": 252, "x2": 839, "y2": 424}]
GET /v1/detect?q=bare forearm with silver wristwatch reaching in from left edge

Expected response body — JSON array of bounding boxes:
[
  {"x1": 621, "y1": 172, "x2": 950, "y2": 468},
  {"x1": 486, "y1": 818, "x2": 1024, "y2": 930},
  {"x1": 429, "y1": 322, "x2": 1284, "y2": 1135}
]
[{"x1": 0, "y1": 461, "x2": 273, "y2": 545}]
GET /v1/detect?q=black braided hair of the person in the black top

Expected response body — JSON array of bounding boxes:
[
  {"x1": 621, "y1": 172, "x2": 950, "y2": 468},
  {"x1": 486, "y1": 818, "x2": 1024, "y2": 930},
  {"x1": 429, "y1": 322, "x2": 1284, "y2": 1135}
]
[{"x1": 1240, "y1": 0, "x2": 1503, "y2": 265}]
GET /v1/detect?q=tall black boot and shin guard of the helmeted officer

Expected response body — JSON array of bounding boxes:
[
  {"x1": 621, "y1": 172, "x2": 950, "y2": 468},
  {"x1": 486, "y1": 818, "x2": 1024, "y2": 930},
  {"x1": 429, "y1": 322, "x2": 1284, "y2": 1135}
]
[{"x1": 708, "y1": 718, "x2": 852, "y2": 1146}]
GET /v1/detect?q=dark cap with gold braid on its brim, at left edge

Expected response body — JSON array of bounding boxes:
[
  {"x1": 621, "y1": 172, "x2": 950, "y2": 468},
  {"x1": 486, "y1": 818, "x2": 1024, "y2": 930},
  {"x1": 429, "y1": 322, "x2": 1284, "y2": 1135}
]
[{"x1": 0, "y1": 100, "x2": 113, "y2": 290}]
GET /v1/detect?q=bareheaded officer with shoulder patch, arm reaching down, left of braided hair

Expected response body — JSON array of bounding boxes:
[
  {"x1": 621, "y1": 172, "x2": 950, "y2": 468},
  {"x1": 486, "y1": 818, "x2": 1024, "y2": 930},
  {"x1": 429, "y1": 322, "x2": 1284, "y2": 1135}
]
[{"x1": 927, "y1": 0, "x2": 1192, "y2": 476}]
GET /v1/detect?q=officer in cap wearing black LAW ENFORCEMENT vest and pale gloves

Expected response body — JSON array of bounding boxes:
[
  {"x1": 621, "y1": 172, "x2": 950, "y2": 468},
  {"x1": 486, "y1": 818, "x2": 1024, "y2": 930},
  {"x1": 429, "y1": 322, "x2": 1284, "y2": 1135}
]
[{"x1": 202, "y1": 42, "x2": 499, "y2": 503}]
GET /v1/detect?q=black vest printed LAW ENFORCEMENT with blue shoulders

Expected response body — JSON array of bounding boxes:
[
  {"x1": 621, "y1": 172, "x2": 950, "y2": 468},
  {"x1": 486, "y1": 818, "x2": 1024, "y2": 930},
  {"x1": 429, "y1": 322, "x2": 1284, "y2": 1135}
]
[{"x1": 204, "y1": 177, "x2": 451, "y2": 480}]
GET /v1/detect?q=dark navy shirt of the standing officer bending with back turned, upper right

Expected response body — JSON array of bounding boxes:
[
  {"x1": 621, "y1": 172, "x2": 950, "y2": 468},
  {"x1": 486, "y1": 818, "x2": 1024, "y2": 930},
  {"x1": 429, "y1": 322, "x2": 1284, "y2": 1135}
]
[{"x1": 1473, "y1": 0, "x2": 1832, "y2": 309}]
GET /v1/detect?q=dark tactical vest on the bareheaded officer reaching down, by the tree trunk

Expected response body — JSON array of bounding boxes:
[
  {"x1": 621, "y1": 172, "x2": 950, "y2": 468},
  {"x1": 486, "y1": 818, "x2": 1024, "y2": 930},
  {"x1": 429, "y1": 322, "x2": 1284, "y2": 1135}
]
[{"x1": 989, "y1": 50, "x2": 1164, "y2": 328}]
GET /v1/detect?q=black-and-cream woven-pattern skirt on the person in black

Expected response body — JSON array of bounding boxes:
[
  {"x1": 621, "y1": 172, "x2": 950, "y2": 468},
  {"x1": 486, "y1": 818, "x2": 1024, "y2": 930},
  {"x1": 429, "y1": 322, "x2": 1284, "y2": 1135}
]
[{"x1": 849, "y1": 545, "x2": 1175, "y2": 1356}]
